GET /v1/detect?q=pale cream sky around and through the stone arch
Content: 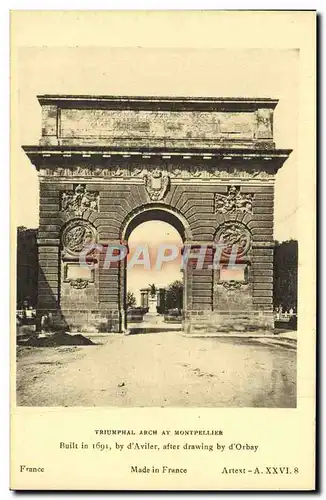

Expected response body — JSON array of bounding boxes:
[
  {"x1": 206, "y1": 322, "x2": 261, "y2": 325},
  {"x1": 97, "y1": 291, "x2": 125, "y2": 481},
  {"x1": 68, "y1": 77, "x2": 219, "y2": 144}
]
[{"x1": 12, "y1": 47, "x2": 300, "y2": 300}]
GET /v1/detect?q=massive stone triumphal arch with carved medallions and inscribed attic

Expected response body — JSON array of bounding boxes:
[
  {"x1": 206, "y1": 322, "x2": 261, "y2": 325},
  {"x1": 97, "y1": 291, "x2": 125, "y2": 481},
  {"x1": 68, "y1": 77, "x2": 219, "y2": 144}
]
[{"x1": 24, "y1": 95, "x2": 290, "y2": 334}]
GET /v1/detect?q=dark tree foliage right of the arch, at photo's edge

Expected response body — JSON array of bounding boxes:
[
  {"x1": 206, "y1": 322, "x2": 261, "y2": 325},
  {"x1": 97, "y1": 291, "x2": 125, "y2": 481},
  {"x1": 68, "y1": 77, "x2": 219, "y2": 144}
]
[{"x1": 274, "y1": 240, "x2": 298, "y2": 311}]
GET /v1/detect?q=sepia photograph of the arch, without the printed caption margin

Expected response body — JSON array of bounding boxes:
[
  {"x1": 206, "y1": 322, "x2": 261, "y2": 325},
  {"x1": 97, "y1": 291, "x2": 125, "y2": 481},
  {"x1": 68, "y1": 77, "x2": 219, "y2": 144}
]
[{"x1": 13, "y1": 46, "x2": 301, "y2": 408}]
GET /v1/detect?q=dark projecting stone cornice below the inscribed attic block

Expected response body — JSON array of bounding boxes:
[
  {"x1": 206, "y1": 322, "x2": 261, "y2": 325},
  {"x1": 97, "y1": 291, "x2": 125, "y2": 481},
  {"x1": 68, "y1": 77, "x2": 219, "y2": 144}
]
[{"x1": 23, "y1": 146, "x2": 291, "y2": 173}]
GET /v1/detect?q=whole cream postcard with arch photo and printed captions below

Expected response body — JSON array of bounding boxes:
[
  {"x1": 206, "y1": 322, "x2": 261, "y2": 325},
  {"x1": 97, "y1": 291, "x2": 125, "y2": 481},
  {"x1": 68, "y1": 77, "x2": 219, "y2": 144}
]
[{"x1": 10, "y1": 10, "x2": 317, "y2": 492}]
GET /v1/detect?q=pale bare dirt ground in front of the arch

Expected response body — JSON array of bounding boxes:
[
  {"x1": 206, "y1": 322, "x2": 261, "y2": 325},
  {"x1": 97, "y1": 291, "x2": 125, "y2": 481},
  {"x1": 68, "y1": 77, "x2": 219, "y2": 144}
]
[{"x1": 17, "y1": 331, "x2": 296, "y2": 407}]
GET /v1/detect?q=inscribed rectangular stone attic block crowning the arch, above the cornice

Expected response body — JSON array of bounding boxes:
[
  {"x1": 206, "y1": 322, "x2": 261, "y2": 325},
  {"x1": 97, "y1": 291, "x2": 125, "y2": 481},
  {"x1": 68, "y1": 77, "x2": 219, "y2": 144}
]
[{"x1": 38, "y1": 95, "x2": 278, "y2": 149}]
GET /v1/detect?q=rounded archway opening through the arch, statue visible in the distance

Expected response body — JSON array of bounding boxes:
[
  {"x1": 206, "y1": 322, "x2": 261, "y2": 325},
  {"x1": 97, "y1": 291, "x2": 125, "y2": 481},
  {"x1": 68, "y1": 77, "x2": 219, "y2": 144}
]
[{"x1": 123, "y1": 208, "x2": 186, "y2": 333}]
